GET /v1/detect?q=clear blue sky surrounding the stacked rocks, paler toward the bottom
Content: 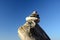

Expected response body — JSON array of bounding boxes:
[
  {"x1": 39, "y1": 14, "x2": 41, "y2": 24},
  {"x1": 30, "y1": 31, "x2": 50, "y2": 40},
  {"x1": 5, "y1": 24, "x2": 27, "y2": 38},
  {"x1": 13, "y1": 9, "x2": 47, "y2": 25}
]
[{"x1": 0, "y1": 0, "x2": 60, "y2": 40}]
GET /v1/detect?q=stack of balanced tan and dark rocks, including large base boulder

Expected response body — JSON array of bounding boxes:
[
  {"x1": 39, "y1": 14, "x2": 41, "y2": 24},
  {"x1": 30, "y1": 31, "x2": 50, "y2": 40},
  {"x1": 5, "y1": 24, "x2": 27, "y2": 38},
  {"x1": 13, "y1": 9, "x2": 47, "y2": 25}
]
[{"x1": 18, "y1": 11, "x2": 50, "y2": 40}]
